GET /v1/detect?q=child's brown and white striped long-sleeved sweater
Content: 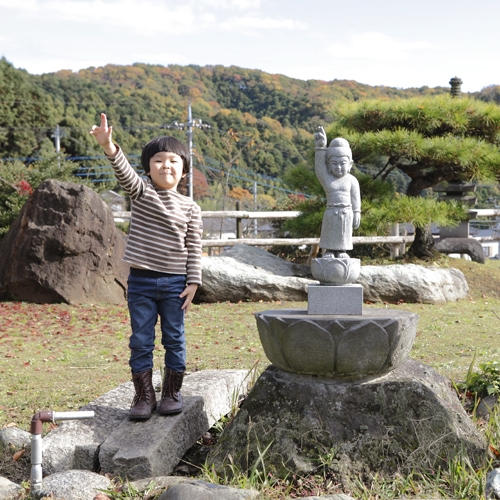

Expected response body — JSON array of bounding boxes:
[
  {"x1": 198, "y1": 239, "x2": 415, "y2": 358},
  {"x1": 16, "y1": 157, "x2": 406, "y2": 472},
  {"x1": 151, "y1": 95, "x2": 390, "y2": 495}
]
[{"x1": 108, "y1": 144, "x2": 203, "y2": 285}]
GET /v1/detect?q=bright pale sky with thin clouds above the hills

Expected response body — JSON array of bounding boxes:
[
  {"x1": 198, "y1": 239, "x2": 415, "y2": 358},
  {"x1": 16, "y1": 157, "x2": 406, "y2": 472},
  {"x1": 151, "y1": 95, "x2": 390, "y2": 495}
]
[{"x1": 0, "y1": 0, "x2": 500, "y2": 92}]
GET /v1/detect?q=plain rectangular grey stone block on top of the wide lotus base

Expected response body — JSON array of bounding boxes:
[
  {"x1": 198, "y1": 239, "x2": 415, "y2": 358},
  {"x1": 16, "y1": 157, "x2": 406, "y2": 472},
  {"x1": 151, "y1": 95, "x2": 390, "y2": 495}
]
[{"x1": 307, "y1": 285, "x2": 363, "y2": 315}]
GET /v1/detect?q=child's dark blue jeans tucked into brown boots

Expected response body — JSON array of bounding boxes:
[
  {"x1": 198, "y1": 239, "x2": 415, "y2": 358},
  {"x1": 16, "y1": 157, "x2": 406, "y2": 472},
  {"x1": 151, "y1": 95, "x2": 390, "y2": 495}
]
[{"x1": 127, "y1": 268, "x2": 186, "y2": 373}]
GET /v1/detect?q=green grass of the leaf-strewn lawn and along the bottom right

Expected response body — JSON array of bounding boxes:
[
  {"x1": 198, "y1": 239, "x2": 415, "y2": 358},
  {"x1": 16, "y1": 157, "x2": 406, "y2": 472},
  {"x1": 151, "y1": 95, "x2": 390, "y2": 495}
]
[{"x1": 0, "y1": 259, "x2": 500, "y2": 499}]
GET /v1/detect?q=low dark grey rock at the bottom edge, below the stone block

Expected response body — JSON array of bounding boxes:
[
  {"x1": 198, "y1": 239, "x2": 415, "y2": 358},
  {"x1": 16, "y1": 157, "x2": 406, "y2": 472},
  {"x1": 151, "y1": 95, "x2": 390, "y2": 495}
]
[{"x1": 159, "y1": 480, "x2": 260, "y2": 500}]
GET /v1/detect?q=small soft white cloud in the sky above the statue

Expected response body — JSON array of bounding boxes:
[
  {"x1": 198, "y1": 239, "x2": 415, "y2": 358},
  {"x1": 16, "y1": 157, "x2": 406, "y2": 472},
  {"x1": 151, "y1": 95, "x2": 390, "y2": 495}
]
[{"x1": 327, "y1": 32, "x2": 433, "y2": 60}]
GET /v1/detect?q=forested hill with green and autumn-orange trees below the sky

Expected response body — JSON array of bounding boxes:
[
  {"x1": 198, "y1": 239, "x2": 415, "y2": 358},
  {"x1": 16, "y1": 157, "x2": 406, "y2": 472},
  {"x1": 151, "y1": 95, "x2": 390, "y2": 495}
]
[{"x1": 0, "y1": 59, "x2": 490, "y2": 198}]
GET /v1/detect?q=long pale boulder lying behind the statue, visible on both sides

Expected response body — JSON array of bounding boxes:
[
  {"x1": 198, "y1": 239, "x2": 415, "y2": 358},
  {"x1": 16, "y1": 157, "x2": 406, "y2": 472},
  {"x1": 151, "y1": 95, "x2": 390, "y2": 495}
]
[{"x1": 195, "y1": 245, "x2": 469, "y2": 304}]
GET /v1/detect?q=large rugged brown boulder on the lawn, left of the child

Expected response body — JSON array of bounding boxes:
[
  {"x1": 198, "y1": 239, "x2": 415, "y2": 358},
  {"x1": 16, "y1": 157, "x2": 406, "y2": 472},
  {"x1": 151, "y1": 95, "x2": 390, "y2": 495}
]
[{"x1": 0, "y1": 180, "x2": 128, "y2": 304}]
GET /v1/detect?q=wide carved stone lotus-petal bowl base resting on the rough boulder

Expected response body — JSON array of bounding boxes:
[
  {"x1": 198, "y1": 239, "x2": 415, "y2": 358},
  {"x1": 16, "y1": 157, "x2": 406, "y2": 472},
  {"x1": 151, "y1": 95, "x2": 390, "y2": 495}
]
[{"x1": 255, "y1": 309, "x2": 418, "y2": 381}]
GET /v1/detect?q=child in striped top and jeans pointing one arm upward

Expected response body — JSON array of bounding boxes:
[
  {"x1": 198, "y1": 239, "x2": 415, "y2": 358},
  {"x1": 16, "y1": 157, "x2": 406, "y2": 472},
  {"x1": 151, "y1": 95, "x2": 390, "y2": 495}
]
[{"x1": 90, "y1": 113, "x2": 202, "y2": 420}]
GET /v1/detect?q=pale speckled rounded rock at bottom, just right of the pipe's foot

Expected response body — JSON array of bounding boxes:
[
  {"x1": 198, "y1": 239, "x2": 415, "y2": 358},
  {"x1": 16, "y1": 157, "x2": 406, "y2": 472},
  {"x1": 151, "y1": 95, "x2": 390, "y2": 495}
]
[{"x1": 42, "y1": 470, "x2": 111, "y2": 500}]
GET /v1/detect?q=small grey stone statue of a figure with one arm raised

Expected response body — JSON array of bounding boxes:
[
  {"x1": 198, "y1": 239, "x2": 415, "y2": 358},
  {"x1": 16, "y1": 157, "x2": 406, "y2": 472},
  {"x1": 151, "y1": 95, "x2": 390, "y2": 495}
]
[{"x1": 314, "y1": 127, "x2": 361, "y2": 259}]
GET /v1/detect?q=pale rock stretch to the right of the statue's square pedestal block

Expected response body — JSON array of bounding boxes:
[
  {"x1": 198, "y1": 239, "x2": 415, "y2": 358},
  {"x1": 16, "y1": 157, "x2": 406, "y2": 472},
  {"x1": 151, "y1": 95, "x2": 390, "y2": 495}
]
[{"x1": 356, "y1": 264, "x2": 469, "y2": 304}]
